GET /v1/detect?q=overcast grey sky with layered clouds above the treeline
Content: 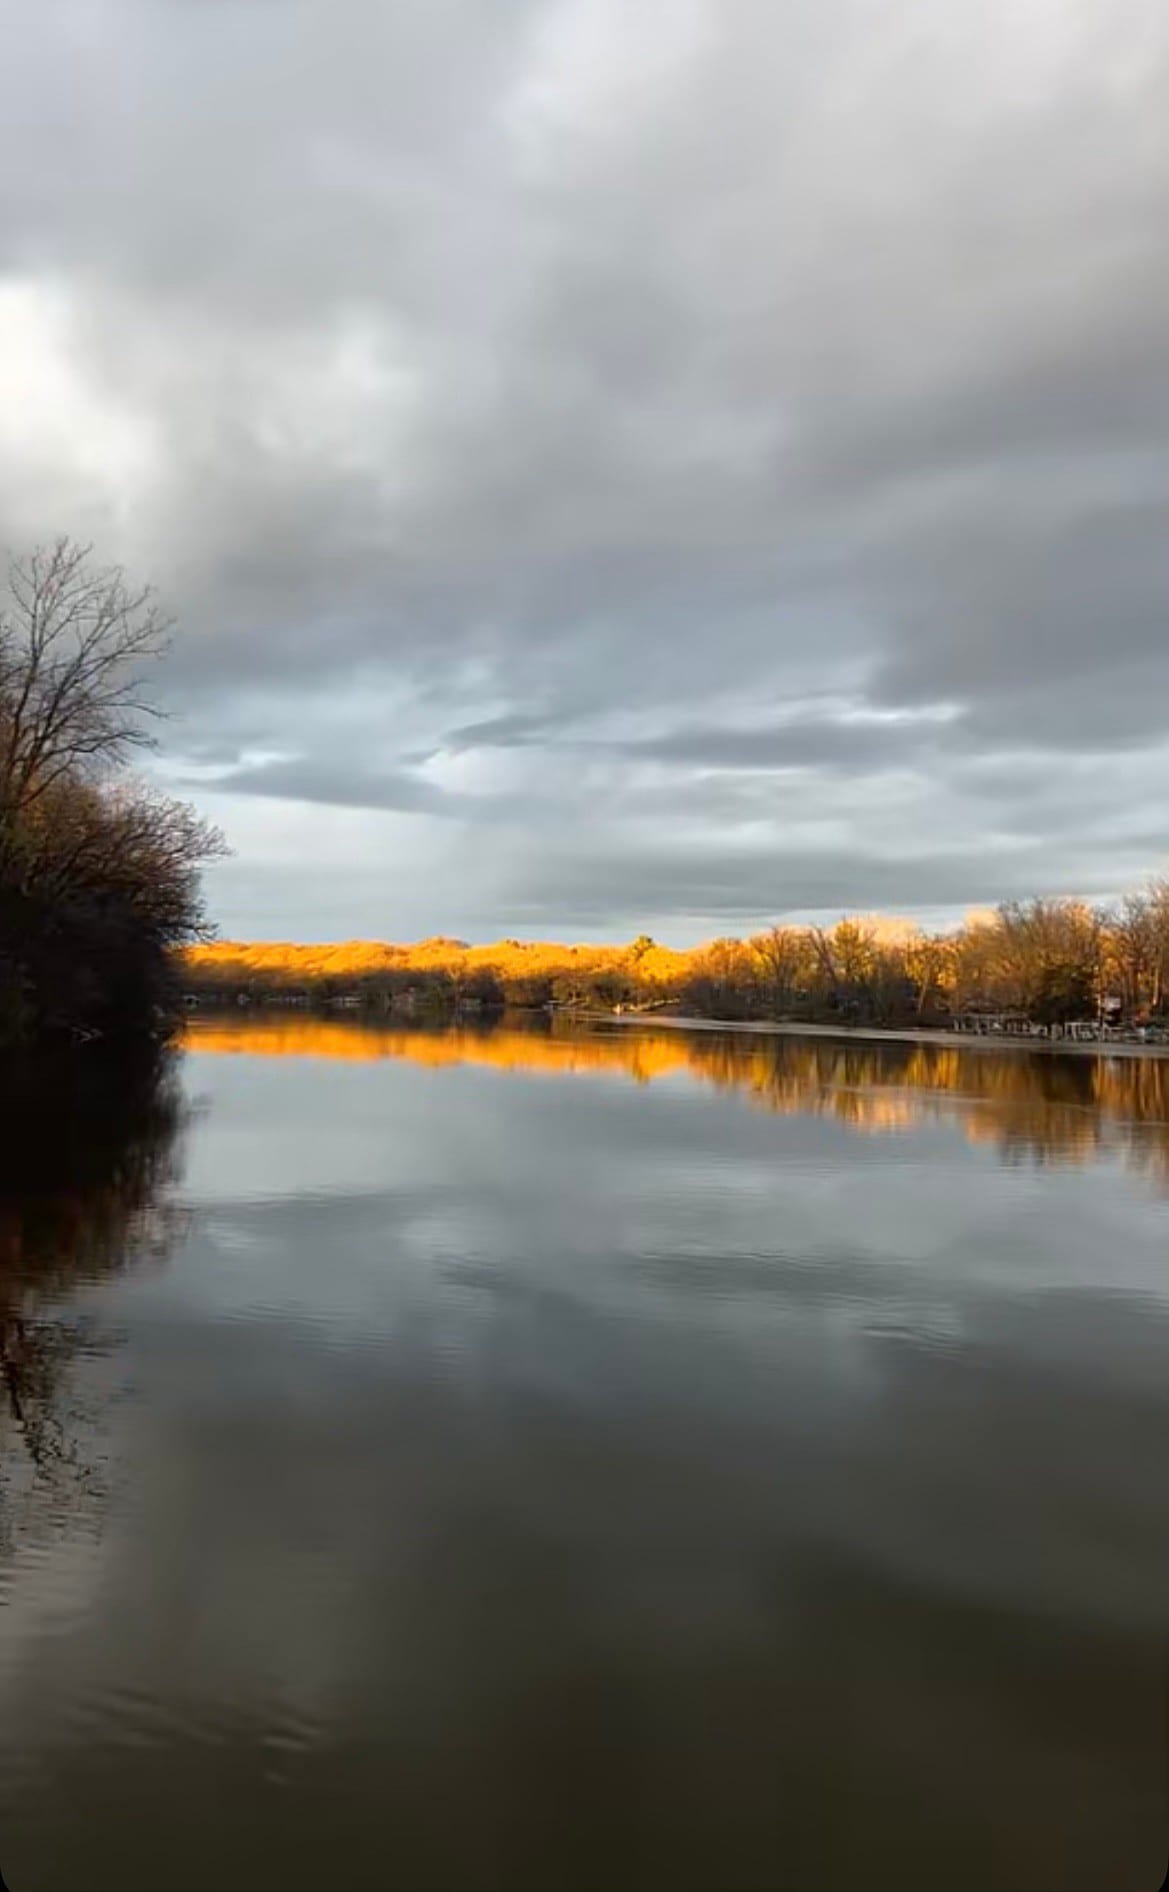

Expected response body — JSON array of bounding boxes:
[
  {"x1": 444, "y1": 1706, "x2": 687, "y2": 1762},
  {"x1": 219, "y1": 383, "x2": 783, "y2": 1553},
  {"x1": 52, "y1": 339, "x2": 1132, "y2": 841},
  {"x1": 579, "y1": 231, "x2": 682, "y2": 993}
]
[{"x1": 0, "y1": 0, "x2": 1169, "y2": 944}]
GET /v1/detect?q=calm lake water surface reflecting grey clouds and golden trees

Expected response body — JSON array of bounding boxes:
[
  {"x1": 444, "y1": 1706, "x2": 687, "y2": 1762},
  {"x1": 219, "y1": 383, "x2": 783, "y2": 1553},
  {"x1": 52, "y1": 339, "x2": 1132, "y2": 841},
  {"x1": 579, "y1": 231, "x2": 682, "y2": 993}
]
[{"x1": 0, "y1": 1022, "x2": 1169, "y2": 1892}]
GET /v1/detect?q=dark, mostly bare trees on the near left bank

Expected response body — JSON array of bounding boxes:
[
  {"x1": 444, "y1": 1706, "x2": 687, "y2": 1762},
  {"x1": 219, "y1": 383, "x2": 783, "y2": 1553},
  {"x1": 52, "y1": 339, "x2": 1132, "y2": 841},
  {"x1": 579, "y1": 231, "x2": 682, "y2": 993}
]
[{"x1": 0, "y1": 539, "x2": 223, "y2": 1042}]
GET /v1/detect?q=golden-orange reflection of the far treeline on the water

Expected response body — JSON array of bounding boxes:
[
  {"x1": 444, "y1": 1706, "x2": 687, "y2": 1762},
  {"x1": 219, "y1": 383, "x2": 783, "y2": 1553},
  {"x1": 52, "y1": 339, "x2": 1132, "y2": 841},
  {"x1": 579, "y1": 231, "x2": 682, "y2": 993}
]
[{"x1": 185, "y1": 1014, "x2": 1169, "y2": 1184}]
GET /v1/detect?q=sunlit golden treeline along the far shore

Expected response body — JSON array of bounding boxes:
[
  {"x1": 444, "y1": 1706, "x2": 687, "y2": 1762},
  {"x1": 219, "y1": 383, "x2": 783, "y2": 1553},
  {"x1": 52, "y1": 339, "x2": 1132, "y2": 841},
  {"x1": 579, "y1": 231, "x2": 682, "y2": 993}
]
[{"x1": 185, "y1": 882, "x2": 1169, "y2": 1024}]
